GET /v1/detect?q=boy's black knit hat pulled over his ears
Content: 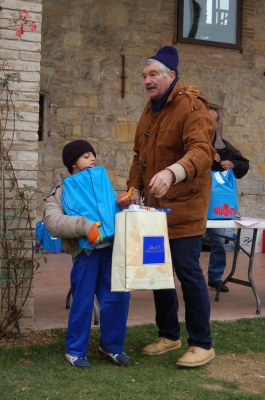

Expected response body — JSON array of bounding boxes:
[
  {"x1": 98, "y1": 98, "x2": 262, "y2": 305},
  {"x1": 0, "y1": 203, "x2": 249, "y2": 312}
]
[{"x1": 62, "y1": 140, "x2": 96, "y2": 174}]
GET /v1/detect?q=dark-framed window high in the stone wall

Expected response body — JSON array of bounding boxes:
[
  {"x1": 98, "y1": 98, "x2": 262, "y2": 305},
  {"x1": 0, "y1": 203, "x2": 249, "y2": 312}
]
[{"x1": 177, "y1": 0, "x2": 243, "y2": 49}]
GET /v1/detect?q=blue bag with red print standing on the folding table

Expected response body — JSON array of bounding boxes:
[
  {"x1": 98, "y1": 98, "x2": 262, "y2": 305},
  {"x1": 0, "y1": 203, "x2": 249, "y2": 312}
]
[{"x1": 207, "y1": 169, "x2": 238, "y2": 219}]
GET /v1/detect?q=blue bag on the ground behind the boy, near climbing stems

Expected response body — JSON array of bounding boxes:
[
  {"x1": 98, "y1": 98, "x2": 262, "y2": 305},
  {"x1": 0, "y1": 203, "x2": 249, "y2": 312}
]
[{"x1": 34, "y1": 221, "x2": 63, "y2": 254}]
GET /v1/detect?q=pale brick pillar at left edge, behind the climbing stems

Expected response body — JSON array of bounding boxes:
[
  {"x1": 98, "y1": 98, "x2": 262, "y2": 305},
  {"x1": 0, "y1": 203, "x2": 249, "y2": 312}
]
[{"x1": 0, "y1": 0, "x2": 42, "y2": 329}]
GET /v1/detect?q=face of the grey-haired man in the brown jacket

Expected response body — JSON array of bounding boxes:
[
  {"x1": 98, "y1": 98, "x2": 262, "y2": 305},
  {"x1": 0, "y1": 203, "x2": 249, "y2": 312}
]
[{"x1": 142, "y1": 62, "x2": 176, "y2": 101}]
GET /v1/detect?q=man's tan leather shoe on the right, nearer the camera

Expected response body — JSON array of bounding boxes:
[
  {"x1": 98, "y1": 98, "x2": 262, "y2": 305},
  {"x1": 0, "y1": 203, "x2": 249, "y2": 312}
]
[{"x1": 177, "y1": 346, "x2": 215, "y2": 367}]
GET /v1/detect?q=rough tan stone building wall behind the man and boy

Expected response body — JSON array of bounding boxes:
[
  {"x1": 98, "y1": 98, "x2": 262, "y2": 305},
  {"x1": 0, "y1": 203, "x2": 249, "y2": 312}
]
[{"x1": 38, "y1": 0, "x2": 265, "y2": 217}]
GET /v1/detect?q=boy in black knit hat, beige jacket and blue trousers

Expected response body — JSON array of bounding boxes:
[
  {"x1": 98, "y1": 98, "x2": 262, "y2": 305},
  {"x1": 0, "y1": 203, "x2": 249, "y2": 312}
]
[{"x1": 44, "y1": 140, "x2": 130, "y2": 368}]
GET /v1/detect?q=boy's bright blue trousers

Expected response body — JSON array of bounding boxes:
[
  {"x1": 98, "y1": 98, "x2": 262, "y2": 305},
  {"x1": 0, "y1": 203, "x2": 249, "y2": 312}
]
[{"x1": 66, "y1": 246, "x2": 130, "y2": 357}]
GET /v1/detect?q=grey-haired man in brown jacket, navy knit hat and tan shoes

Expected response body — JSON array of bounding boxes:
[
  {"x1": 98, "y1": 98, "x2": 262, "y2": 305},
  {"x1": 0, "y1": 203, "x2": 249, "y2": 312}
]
[{"x1": 127, "y1": 46, "x2": 215, "y2": 367}]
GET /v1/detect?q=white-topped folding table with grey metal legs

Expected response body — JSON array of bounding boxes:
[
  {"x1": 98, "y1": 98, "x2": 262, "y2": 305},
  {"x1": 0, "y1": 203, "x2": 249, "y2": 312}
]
[{"x1": 207, "y1": 217, "x2": 265, "y2": 314}]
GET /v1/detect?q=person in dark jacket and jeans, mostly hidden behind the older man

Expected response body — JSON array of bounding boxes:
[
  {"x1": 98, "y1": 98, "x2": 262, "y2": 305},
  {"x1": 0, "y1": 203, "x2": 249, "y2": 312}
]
[{"x1": 207, "y1": 109, "x2": 249, "y2": 292}]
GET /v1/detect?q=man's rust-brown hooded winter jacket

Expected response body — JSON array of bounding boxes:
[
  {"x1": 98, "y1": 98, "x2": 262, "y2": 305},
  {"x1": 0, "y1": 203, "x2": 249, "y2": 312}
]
[{"x1": 127, "y1": 81, "x2": 215, "y2": 239}]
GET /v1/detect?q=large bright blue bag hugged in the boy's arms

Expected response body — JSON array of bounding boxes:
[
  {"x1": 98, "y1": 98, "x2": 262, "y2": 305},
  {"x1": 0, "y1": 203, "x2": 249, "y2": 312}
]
[{"x1": 61, "y1": 166, "x2": 121, "y2": 250}]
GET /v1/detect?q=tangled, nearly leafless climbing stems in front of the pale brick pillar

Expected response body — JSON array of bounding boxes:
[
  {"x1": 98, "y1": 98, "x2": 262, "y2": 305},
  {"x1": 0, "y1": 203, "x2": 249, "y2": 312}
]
[{"x1": 0, "y1": 61, "x2": 39, "y2": 338}]
